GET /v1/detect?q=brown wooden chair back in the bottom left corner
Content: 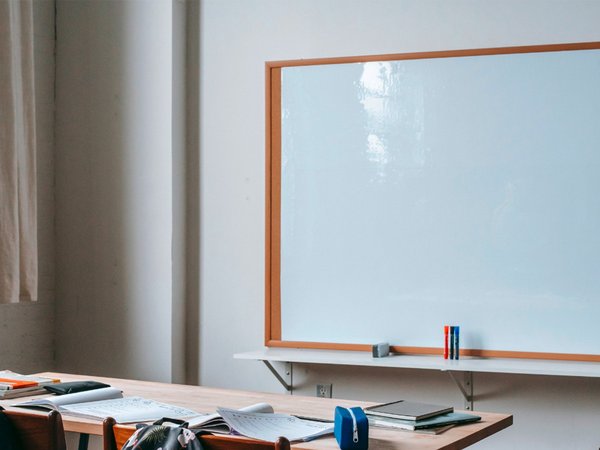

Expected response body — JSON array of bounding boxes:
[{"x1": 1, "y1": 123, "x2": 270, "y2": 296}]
[{"x1": 2, "y1": 410, "x2": 67, "y2": 450}]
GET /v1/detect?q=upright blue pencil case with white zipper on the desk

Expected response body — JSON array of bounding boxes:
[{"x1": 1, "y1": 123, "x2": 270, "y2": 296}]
[{"x1": 333, "y1": 406, "x2": 369, "y2": 450}]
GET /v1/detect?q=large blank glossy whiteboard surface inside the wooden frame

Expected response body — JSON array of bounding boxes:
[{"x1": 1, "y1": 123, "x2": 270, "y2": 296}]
[{"x1": 264, "y1": 43, "x2": 600, "y2": 359}]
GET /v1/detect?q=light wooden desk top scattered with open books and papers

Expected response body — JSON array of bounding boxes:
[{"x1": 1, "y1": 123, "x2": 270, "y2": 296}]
[{"x1": 0, "y1": 372, "x2": 512, "y2": 450}]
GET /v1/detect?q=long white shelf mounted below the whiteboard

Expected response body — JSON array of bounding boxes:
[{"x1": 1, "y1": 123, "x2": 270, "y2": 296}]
[{"x1": 233, "y1": 348, "x2": 600, "y2": 378}]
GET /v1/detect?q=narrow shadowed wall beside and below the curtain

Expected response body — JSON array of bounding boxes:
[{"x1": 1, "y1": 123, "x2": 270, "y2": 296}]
[{"x1": 0, "y1": 1, "x2": 55, "y2": 373}]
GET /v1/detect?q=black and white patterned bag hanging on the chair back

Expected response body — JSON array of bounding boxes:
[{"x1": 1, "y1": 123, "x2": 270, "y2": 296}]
[{"x1": 122, "y1": 418, "x2": 204, "y2": 450}]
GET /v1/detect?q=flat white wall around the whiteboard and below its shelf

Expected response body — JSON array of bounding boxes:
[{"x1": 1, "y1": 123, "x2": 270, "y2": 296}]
[{"x1": 199, "y1": 0, "x2": 600, "y2": 449}]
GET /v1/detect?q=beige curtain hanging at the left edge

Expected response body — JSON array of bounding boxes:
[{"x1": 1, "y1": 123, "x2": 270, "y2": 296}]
[{"x1": 0, "y1": 0, "x2": 38, "y2": 303}]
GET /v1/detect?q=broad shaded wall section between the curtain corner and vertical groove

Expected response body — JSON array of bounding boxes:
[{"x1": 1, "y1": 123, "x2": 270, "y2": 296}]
[{"x1": 56, "y1": 0, "x2": 181, "y2": 381}]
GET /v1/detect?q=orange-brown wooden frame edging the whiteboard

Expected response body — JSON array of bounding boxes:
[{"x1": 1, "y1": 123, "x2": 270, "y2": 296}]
[{"x1": 264, "y1": 42, "x2": 600, "y2": 362}]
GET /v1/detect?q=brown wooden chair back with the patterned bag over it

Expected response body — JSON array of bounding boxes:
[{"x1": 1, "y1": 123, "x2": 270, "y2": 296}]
[{"x1": 102, "y1": 417, "x2": 290, "y2": 450}]
